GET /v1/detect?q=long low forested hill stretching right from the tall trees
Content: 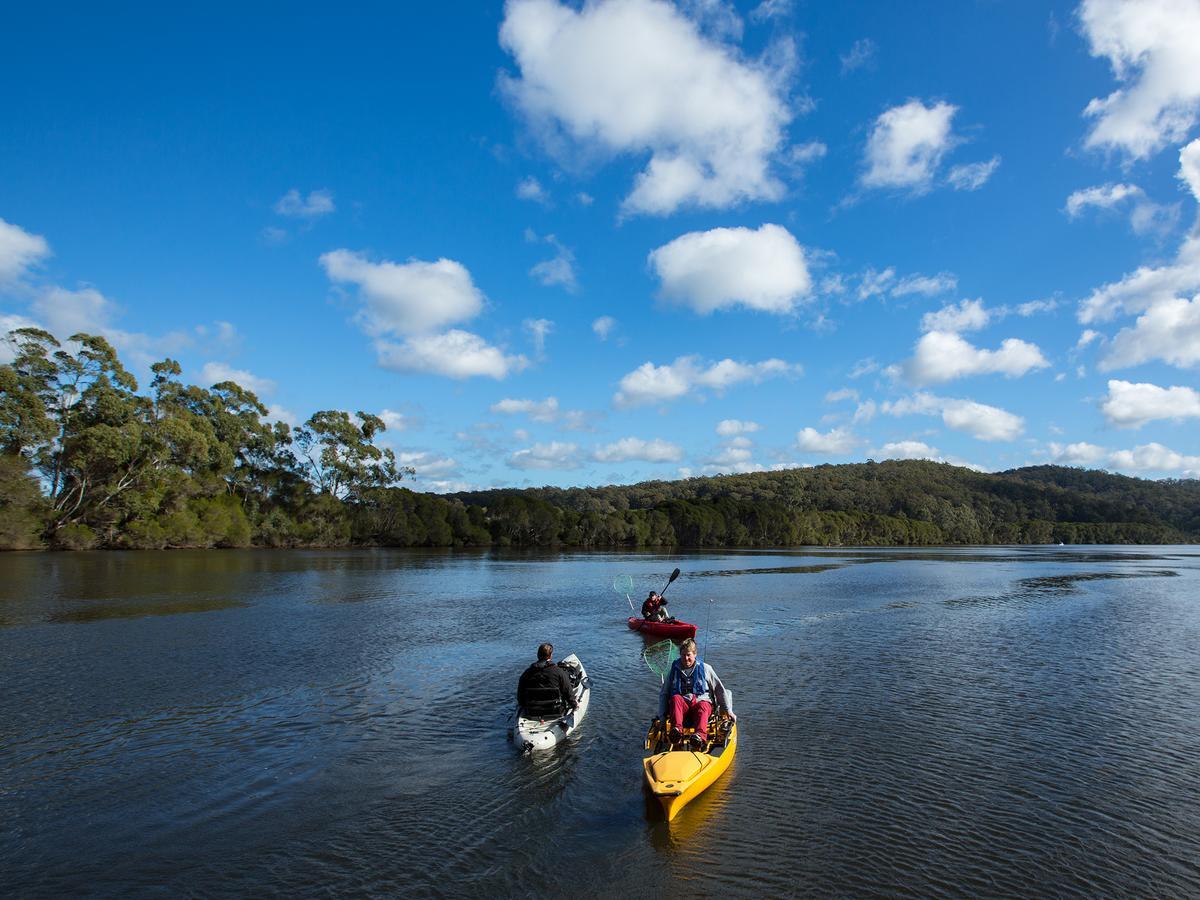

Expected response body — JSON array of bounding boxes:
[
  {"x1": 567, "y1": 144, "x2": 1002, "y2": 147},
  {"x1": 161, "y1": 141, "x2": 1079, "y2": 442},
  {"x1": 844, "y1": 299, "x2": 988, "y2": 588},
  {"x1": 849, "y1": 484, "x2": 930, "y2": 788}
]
[{"x1": 456, "y1": 460, "x2": 1200, "y2": 546}]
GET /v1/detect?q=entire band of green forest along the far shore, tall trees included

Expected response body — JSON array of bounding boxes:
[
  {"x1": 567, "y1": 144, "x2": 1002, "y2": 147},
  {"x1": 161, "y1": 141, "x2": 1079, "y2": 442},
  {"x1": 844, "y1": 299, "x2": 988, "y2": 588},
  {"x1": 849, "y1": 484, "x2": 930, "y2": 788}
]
[{"x1": 0, "y1": 329, "x2": 1200, "y2": 550}]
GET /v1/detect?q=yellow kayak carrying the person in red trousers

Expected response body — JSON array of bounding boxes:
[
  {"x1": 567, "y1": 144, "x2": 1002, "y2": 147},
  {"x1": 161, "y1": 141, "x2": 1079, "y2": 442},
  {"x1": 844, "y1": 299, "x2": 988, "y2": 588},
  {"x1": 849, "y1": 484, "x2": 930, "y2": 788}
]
[{"x1": 642, "y1": 713, "x2": 738, "y2": 822}]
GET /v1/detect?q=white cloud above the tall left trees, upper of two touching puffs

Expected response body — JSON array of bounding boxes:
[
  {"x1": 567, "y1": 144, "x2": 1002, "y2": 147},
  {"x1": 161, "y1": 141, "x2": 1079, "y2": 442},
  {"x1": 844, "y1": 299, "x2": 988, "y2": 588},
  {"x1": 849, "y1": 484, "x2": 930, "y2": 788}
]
[{"x1": 320, "y1": 250, "x2": 484, "y2": 337}]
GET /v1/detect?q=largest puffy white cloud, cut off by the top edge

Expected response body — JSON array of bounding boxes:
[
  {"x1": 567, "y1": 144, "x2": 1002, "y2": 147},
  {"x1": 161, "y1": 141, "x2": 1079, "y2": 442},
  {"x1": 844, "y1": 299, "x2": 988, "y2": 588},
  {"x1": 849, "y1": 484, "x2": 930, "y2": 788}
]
[{"x1": 500, "y1": 0, "x2": 791, "y2": 215}]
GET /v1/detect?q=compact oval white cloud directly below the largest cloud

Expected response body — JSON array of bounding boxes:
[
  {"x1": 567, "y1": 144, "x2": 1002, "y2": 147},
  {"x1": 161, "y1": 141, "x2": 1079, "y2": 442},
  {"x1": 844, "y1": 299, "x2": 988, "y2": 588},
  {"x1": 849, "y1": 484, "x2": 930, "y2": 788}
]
[{"x1": 649, "y1": 224, "x2": 812, "y2": 316}]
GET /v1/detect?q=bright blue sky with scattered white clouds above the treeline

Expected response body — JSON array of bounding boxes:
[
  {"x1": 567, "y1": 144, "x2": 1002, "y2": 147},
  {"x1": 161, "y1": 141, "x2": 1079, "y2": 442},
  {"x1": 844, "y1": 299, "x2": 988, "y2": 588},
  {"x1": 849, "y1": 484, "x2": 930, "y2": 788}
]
[{"x1": 0, "y1": 0, "x2": 1200, "y2": 491}]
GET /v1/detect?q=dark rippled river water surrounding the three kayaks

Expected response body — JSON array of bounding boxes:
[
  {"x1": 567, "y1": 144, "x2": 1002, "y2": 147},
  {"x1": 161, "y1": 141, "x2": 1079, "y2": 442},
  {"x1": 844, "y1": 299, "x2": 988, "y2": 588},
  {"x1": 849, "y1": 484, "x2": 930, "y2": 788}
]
[{"x1": 0, "y1": 547, "x2": 1200, "y2": 896}]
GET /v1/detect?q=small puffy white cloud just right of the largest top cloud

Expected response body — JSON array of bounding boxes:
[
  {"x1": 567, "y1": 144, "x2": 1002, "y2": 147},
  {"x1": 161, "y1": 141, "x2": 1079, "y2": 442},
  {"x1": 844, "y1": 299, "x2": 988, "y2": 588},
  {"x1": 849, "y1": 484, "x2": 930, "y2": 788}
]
[{"x1": 860, "y1": 100, "x2": 958, "y2": 193}]
